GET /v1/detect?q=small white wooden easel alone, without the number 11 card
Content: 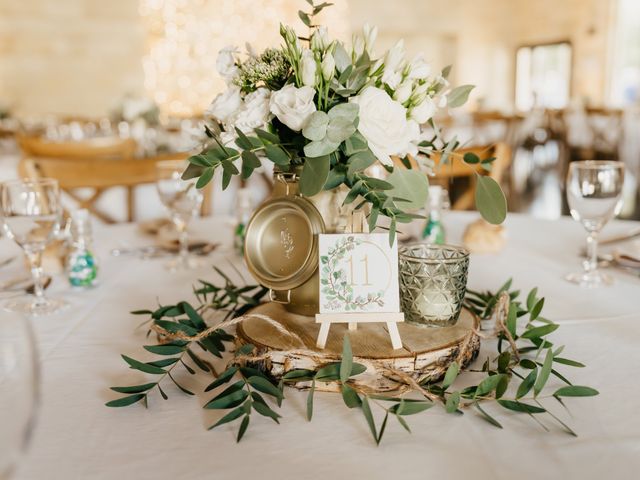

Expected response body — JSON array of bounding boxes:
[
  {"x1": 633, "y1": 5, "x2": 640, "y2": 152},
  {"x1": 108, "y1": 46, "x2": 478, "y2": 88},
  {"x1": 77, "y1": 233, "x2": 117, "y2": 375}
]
[{"x1": 316, "y1": 210, "x2": 404, "y2": 350}]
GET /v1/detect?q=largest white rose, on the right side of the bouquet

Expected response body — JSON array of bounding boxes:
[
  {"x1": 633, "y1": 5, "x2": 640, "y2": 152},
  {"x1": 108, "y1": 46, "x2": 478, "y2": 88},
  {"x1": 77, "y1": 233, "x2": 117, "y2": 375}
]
[{"x1": 350, "y1": 87, "x2": 420, "y2": 165}]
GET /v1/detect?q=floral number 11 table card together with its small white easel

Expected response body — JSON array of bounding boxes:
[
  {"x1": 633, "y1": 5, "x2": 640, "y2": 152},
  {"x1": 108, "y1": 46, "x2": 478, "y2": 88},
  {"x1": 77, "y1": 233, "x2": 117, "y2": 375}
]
[{"x1": 316, "y1": 233, "x2": 404, "y2": 349}]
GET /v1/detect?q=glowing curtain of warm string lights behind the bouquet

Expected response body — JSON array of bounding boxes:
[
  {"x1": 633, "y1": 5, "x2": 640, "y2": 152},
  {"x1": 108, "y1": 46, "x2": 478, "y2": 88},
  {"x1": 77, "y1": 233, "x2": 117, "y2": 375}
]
[{"x1": 140, "y1": 0, "x2": 348, "y2": 116}]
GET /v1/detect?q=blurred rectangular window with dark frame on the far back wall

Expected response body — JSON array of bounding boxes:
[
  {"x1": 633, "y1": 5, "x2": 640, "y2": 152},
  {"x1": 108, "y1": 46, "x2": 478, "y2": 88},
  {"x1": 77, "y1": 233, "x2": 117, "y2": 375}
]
[{"x1": 516, "y1": 42, "x2": 571, "y2": 111}]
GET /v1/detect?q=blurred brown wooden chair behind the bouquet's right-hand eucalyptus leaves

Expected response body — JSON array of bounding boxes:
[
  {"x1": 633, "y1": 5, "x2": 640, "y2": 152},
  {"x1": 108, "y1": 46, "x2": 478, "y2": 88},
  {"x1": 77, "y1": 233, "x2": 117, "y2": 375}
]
[{"x1": 410, "y1": 143, "x2": 511, "y2": 210}]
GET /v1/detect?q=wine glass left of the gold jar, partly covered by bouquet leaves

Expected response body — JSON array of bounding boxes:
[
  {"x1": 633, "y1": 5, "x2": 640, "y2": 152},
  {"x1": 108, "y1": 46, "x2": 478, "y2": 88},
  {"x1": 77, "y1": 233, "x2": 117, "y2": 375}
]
[{"x1": 156, "y1": 160, "x2": 202, "y2": 271}]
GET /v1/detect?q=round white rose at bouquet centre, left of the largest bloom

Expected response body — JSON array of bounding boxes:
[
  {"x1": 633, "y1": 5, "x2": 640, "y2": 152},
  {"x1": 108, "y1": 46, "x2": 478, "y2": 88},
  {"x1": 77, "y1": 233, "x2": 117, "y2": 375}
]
[{"x1": 269, "y1": 84, "x2": 316, "y2": 132}]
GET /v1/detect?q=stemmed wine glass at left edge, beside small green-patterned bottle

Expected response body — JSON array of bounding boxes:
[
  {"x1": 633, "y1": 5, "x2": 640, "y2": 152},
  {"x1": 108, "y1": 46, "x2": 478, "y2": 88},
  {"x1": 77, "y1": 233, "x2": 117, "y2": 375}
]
[{"x1": 0, "y1": 178, "x2": 67, "y2": 316}]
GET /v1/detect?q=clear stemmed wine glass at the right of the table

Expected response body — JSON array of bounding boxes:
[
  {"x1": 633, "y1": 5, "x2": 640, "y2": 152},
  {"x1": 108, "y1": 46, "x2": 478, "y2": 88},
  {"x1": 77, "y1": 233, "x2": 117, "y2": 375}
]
[{"x1": 566, "y1": 160, "x2": 624, "y2": 288}]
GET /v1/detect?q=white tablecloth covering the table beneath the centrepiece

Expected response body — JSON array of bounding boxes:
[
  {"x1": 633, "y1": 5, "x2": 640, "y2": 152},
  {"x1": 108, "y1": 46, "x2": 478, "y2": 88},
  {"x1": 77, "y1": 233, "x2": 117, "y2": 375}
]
[{"x1": 0, "y1": 214, "x2": 640, "y2": 480}]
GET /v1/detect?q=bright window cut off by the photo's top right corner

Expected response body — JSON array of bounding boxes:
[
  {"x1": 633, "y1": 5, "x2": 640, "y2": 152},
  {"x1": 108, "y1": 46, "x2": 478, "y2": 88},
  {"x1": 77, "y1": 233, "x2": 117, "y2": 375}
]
[{"x1": 610, "y1": 0, "x2": 640, "y2": 107}]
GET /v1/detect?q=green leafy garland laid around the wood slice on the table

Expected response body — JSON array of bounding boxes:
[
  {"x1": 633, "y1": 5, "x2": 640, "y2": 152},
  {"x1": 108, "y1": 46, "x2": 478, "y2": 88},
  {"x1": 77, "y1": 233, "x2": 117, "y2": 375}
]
[{"x1": 106, "y1": 269, "x2": 598, "y2": 444}]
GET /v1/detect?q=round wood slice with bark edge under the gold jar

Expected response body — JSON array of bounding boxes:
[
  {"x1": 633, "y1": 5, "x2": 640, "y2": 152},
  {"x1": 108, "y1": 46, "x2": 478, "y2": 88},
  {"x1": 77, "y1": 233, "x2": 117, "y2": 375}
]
[{"x1": 238, "y1": 303, "x2": 480, "y2": 392}]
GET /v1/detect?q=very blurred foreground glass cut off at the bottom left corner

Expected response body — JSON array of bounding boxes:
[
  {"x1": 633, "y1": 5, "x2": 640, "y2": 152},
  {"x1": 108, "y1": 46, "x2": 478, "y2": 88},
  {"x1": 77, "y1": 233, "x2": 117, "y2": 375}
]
[{"x1": 0, "y1": 312, "x2": 39, "y2": 479}]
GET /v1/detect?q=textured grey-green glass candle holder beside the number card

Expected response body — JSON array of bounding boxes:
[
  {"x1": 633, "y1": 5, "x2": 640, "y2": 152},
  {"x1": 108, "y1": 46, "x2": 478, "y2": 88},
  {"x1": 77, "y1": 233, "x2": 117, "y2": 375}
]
[{"x1": 398, "y1": 243, "x2": 469, "y2": 327}]
